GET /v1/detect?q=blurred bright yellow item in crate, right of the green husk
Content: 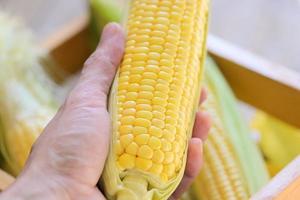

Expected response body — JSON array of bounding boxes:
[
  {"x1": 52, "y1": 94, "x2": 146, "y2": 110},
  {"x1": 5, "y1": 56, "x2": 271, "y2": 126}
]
[{"x1": 252, "y1": 111, "x2": 300, "y2": 176}]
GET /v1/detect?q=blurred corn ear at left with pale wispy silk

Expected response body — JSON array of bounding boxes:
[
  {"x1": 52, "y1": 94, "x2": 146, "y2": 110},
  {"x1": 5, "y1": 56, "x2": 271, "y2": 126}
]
[{"x1": 0, "y1": 14, "x2": 58, "y2": 175}]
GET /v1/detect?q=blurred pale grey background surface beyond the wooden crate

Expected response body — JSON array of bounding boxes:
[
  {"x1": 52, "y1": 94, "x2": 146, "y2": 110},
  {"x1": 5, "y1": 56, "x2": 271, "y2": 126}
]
[{"x1": 0, "y1": 0, "x2": 300, "y2": 71}]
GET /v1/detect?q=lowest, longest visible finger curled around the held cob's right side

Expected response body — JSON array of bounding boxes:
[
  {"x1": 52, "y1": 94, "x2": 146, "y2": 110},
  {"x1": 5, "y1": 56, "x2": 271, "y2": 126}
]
[{"x1": 170, "y1": 138, "x2": 203, "y2": 199}]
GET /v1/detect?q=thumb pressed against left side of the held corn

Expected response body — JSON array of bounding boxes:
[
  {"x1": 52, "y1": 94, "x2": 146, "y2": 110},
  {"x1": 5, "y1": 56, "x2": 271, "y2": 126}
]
[{"x1": 68, "y1": 23, "x2": 125, "y2": 109}]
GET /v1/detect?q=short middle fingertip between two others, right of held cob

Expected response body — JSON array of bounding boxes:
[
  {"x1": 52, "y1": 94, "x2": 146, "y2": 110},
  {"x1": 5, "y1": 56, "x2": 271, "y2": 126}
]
[{"x1": 193, "y1": 111, "x2": 211, "y2": 141}]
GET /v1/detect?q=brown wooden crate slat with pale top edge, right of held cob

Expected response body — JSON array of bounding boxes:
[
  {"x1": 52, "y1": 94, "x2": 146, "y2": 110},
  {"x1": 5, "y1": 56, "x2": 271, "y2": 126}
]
[{"x1": 208, "y1": 35, "x2": 300, "y2": 127}]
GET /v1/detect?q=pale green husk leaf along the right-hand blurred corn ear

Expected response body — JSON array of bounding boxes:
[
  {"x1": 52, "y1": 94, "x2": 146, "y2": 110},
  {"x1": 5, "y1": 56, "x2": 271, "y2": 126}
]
[{"x1": 205, "y1": 59, "x2": 269, "y2": 195}]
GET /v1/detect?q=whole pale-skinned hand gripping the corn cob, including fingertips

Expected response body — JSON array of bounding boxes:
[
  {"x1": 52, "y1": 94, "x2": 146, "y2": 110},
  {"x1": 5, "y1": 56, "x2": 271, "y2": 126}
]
[{"x1": 0, "y1": 23, "x2": 210, "y2": 200}]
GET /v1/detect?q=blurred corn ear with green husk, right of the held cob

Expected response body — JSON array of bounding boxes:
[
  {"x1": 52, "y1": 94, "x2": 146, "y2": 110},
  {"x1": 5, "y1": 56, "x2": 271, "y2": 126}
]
[{"x1": 184, "y1": 59, "x2": 268, "y2": 200}]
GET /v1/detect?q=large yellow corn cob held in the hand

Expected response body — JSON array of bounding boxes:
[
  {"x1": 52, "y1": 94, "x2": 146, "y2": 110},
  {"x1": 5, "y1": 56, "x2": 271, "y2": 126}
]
[{"x1": 102, "y1": 0, "x2": 208, "y2": 199}]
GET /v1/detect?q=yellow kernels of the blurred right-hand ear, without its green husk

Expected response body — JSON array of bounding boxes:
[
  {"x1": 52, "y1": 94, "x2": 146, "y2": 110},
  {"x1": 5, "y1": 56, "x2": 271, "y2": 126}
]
[{"x1": 192, "y1": 90, "x2": 249, "y2": 200}]
